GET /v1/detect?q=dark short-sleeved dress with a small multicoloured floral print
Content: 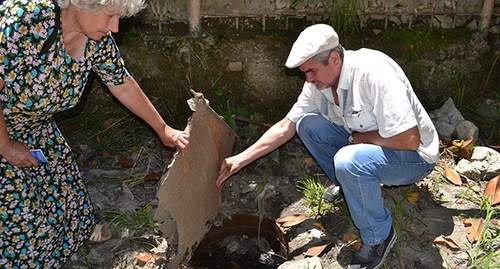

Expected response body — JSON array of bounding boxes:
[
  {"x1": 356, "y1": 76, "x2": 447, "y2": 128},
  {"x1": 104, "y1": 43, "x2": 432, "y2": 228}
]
[{"x1": 0, "y1": 0, "x2": 129, "y2": 268}]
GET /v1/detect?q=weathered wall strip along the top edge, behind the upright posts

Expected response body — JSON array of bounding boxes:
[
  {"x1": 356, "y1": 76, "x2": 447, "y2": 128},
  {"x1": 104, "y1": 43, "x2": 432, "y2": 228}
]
[{"x1": 143, "y1": 0, "x2": 500, "y2": 31}]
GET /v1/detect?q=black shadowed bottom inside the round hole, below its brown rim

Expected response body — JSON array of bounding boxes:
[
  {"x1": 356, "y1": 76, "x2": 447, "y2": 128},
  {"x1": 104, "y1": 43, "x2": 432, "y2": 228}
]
[{"x1": 194, "y1": 238, "x2": 285, "y2": 269}]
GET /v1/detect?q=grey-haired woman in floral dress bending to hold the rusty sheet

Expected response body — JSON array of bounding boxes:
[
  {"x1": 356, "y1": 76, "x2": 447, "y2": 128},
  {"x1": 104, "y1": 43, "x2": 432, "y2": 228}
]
[{"x1": 0, "y1": 0, "x2": 189, "y2": 268}]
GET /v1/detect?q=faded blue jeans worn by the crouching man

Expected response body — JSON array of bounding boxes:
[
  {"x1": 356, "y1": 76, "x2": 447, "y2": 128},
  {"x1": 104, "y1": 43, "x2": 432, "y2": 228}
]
[{"x1": 297, "y1": 113, "x2": 435, "y2": 245}]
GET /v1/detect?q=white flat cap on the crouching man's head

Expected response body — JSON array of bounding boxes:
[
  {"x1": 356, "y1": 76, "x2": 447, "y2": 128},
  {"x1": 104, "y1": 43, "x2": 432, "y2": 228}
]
[{"x1": 285, "y1": 24, "x2": 339, "y2": 68}]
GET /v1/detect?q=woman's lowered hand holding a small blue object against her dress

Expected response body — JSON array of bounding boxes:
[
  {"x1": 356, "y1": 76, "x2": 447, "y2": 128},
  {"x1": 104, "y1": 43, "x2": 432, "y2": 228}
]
[{"x1": 0, "y1": 140, "x2": 38, "y2": 167}]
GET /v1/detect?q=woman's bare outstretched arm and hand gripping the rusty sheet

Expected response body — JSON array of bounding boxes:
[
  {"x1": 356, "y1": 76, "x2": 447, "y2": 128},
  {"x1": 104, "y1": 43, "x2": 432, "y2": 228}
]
[{"x1": 108, "y1": 77, "x2": 189, "y2": 155}]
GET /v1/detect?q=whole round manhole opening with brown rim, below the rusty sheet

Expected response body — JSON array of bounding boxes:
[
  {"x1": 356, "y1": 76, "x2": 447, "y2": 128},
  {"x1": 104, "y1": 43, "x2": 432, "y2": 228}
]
[{"x1": 190, "y1": 214, "x2": 289, "y2": 269}]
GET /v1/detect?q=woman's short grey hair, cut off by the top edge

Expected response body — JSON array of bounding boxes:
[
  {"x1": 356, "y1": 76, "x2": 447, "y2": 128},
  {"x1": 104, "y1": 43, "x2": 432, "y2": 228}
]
[{"x1": 57, "y1": 0, "x2": 146, "y2": 17}]
